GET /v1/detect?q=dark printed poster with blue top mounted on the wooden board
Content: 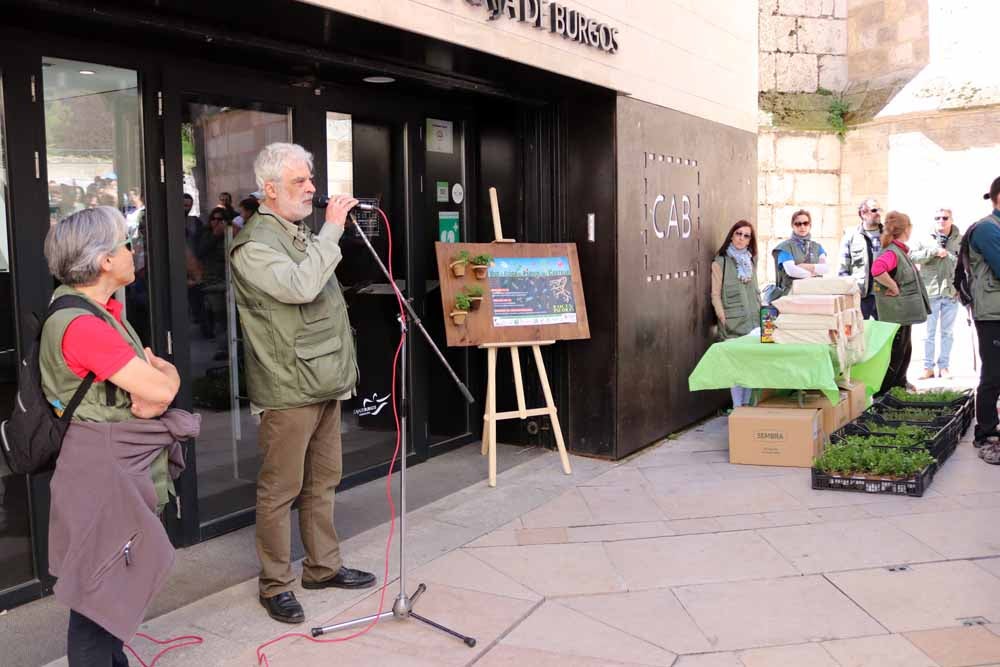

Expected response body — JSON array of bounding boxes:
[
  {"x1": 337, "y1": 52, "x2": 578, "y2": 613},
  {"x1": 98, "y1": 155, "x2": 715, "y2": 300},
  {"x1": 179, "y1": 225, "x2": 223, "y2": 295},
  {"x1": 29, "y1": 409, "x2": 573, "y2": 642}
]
[{"x1": 489, "y1": 257, "x2": 576, "y2": 327}]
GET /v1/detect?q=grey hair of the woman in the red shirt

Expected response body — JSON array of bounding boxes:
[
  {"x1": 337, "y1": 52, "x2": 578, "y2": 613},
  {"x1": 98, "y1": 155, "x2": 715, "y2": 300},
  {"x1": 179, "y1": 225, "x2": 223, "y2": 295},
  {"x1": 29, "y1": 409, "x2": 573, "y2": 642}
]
[{"x1": 45, "y1": 206, "x2": 128, "y2": 287}]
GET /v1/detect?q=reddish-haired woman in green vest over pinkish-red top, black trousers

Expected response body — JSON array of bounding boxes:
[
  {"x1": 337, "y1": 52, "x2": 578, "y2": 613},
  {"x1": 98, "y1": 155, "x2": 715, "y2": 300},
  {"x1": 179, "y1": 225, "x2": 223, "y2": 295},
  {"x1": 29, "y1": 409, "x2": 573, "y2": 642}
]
[{"x1": 872, "y1": 211, "x2": 931, "y2": 396}]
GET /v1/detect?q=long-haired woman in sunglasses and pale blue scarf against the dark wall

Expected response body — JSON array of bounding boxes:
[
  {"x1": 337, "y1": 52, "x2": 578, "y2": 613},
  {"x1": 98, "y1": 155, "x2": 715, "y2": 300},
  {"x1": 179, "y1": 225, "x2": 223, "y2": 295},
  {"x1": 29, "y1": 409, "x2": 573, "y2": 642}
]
[{"x1": 712, "y1": 220, "x2": 760, "y2": 408}]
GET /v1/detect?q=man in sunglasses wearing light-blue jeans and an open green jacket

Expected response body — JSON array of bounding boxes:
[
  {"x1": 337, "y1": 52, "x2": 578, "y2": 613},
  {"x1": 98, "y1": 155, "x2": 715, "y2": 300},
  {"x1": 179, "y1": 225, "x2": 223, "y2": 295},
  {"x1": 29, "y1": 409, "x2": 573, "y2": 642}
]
[{"x1": 910, "y1": 208, "x2": 962, "y2": 380}]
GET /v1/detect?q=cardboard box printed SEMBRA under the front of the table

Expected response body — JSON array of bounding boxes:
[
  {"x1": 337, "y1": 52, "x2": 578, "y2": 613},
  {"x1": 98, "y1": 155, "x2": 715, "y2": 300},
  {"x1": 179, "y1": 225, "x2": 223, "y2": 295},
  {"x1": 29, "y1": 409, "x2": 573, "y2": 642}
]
[{"x1": 729, "y1": 408, "x2": 823, "y2": 468}]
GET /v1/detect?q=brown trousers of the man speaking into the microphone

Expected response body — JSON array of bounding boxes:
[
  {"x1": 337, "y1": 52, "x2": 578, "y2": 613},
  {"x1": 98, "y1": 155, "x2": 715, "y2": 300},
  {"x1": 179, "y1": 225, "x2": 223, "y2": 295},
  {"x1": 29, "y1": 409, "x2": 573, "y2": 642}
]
[{"x1": 257, "y1": 401, "x2": 343, "y2": 597}]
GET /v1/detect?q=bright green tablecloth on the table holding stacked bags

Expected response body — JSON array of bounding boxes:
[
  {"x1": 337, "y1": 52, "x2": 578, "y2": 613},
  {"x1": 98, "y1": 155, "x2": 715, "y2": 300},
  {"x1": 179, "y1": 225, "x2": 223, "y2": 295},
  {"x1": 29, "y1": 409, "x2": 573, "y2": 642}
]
[{"x1": 688, "y1": 320, "x2": 899, "y2": 403}]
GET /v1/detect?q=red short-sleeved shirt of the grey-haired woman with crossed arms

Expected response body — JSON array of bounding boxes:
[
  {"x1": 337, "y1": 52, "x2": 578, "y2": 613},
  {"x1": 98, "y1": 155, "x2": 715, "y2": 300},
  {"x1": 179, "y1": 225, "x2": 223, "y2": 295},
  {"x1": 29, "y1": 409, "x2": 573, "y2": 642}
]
[{"x1": 62, "y1": 298, "x2": 136, "y2": 382}]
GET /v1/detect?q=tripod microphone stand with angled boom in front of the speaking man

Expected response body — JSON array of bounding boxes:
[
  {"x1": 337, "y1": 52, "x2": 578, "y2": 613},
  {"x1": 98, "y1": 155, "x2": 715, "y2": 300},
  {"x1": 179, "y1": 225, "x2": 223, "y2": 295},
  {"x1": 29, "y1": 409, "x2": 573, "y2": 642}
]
[{"x1": 310, "y1": 213, "x2": 476, "y2": 648}]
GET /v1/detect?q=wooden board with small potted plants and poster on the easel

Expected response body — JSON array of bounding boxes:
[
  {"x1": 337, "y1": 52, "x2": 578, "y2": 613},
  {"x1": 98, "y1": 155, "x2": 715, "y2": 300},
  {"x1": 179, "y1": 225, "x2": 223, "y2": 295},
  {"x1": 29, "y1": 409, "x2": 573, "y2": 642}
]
[{"x1": 435, "y1": 242, "x2": 590, "y2": 347}]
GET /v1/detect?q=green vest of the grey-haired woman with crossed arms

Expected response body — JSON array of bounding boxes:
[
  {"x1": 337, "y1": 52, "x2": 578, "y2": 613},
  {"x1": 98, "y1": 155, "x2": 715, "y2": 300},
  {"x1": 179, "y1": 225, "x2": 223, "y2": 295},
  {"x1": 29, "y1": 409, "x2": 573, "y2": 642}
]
[{"x1": 38, "y1": 285, "x2": 176, "y2": 513}]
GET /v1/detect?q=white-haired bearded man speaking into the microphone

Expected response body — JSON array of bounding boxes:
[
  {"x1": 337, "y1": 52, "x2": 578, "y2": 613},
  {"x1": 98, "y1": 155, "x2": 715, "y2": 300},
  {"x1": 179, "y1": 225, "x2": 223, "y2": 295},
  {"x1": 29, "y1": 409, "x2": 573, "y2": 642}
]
[{"x1": 230, "y1": 143, "x2": 375, "y2": 623}]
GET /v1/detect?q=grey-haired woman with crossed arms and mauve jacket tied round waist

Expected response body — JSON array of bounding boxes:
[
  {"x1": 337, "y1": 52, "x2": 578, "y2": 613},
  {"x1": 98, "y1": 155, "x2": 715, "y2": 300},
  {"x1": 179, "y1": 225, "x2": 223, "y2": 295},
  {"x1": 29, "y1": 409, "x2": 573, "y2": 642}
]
[{"x1": 39, "y1": 206, "x2": 199, "y2": 667}]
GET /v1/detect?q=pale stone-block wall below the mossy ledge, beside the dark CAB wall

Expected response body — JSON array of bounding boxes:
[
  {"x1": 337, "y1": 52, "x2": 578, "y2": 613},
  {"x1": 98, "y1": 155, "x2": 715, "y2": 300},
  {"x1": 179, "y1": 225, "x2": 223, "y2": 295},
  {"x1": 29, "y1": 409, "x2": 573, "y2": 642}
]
[{"x1": 757, "y1": 128, "x2": 842, "y2": 285}]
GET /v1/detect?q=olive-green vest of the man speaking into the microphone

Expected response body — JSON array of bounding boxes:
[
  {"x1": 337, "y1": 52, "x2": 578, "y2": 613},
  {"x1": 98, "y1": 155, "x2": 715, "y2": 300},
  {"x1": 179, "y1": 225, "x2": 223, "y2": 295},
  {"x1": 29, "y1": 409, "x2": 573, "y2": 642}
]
[{"x1": 230, "y1": 213, "x2": 358, "y2": 410}]
